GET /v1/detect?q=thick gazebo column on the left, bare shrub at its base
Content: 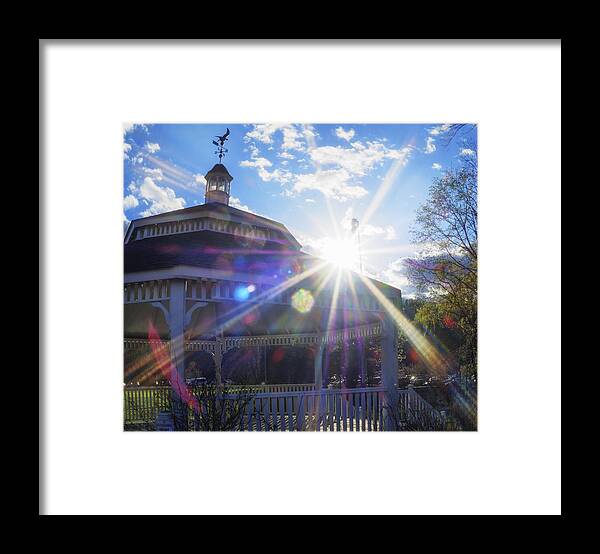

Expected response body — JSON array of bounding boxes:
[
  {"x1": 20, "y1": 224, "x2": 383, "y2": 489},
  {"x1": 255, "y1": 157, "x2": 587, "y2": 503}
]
[{"x1": 169, "y1": 279, "x2": 187, "y2": 431}]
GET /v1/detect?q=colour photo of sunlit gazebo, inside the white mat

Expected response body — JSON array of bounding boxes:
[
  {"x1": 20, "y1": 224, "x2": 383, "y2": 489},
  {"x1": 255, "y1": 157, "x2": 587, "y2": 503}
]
[{"x1": 122, "y1": 121, "x2": 478, "y2": 432}]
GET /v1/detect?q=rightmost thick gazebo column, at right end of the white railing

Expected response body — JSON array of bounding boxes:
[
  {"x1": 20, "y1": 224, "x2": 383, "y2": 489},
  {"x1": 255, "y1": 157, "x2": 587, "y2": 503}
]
[{"x1": 381, "y1": 313, "x2": 398, "y2": 431}]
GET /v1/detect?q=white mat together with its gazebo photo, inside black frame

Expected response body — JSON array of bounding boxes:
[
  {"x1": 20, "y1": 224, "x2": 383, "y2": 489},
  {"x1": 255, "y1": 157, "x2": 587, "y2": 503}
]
[{"x1": 39, "y1": 38, "x2": 566, "y2": 517}]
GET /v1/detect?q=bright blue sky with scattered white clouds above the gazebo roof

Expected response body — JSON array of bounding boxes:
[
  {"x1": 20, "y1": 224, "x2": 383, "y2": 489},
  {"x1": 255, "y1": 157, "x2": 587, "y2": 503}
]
[{"x1": 123, "y1": 123, "x2": 476, "y2": 297}]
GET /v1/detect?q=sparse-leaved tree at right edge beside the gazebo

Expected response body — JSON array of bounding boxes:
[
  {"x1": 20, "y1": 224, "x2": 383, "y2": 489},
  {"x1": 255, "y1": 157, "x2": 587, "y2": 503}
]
[{"x1": 405, "y1": 149, "x2": 477, "y2": 374}]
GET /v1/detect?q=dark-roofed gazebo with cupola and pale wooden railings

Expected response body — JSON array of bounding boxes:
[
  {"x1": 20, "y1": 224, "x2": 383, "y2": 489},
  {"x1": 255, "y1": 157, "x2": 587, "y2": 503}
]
[{"x1": 124, "y1": 152, "x2": 432, "y2": 430}]
